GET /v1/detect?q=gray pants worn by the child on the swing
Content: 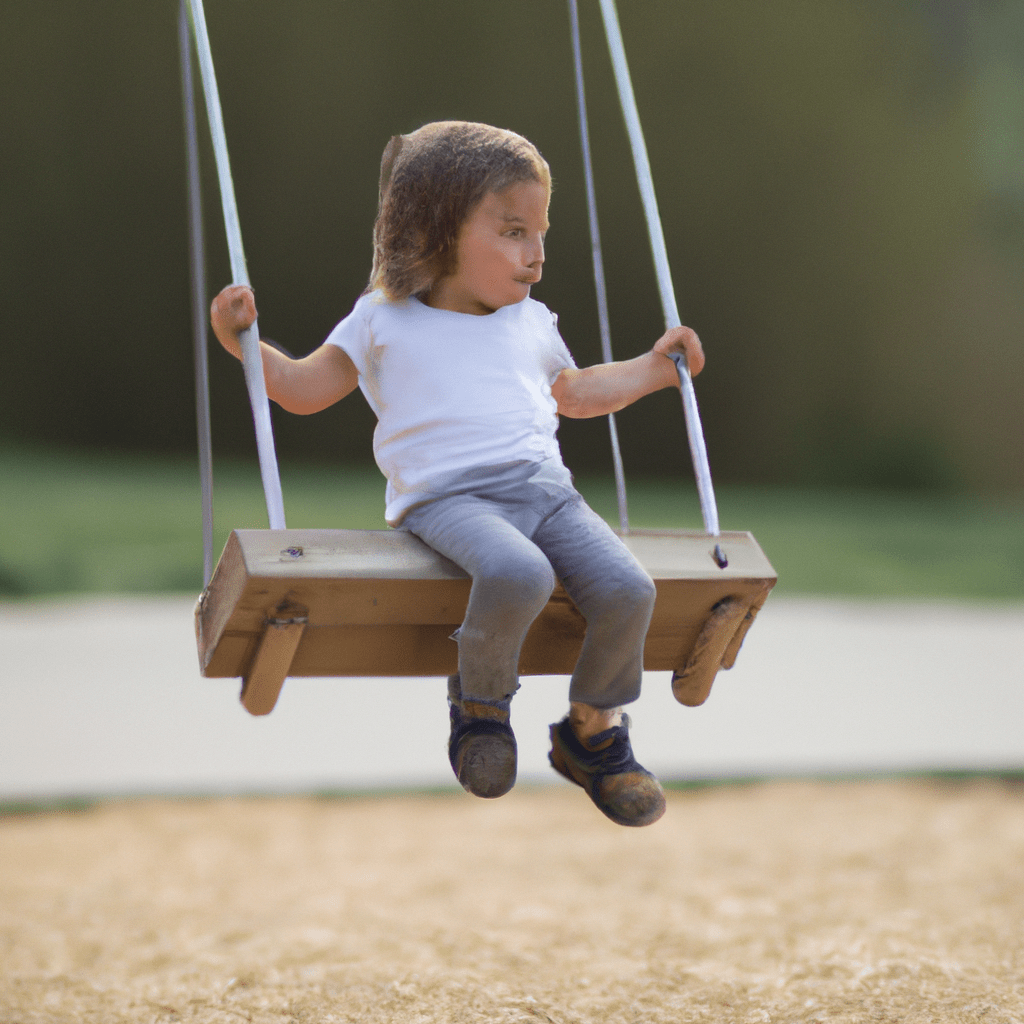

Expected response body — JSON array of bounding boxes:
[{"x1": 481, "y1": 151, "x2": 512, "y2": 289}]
[{"x1": 401, "y1": 473, "x2": 654, "y2": 709}]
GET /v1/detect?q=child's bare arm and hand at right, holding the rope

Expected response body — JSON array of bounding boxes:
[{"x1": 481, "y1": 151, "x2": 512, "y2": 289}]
[{"x1": 551, "y1": 327, "x2": 705, "y2": 420}]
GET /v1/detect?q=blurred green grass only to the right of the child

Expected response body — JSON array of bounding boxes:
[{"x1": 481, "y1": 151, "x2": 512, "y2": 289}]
[{"x1": 582, "y1": 481, "x2": 1024, "y2": 601}]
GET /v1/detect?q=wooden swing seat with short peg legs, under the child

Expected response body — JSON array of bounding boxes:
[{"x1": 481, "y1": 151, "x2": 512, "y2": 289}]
[{"x1": 196, "y1": 529, "x2": 776, "y2": 715}]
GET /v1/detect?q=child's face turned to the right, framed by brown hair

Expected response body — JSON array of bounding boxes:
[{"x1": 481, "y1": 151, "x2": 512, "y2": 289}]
[{"x1": 427, "y1": 181, "x2": 551, "y2": 316}]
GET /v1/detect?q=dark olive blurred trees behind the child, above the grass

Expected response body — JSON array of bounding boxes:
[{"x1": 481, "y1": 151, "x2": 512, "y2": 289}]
[{"x1": 0, "y1": 0, "x2": 1024, "y2": 492}]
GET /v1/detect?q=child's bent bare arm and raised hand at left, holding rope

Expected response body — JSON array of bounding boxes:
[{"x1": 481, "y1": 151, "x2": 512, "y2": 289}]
[{"x1": 210, "y1": 285, "x2": 359, "y2": 415}]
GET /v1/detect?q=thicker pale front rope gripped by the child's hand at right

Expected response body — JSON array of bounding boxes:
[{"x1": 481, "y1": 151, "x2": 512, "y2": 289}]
[{"x1": 600, "y1": 0, "x2": 728, "y2": 568}]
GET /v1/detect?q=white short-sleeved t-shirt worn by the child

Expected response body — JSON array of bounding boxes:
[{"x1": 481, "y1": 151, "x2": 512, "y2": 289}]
[{"x1": 325, "y1": 292, "x2": 575, "y2": 525}]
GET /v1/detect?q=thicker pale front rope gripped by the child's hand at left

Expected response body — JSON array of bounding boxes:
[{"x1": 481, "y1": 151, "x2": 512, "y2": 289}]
[{"x1": 188, "y1": 0, "x2": 285, "y2": 529}]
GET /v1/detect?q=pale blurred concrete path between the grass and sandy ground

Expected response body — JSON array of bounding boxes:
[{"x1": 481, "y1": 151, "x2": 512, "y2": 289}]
[{"x1": 0, "y1": 597, "x2": 1024, "y2": 800}]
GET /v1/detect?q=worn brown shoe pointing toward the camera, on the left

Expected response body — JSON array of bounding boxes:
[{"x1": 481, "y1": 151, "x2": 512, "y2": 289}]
[{"x1": 449, "y1": 676, "x2": 517, "y2": 800}]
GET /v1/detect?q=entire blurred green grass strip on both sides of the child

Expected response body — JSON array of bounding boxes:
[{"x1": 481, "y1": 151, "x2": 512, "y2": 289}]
[{"x1": 0, "y1": 449, "x2": 1024, "y2": 601}]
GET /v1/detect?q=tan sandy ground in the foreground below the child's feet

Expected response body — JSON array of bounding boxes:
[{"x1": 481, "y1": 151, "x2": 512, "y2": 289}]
[{"x1": 0, "y1": 781, "x2": 1024, "y2": 1024}]
